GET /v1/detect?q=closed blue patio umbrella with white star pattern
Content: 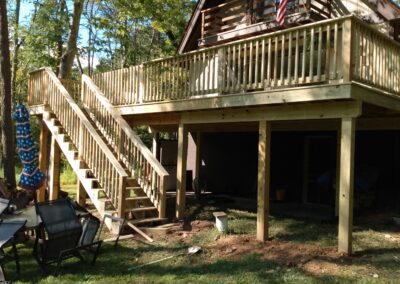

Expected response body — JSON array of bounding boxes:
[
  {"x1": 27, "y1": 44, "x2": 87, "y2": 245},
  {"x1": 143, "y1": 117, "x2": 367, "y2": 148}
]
[{"x1": 13, "y1": 104, "x2": 46, "y2": 190}]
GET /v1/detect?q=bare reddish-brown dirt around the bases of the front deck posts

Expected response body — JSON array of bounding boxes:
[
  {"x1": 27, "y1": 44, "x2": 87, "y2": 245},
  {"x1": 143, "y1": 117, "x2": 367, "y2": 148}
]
[{"x1": 147, "y1": 220, "x2": 349, "y2": 276}]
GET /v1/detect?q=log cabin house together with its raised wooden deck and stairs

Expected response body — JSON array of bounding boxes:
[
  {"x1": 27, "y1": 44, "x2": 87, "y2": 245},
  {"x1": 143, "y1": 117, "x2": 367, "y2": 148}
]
[{"x1": 29, "y1": 0, "x2": 400, "y2": 253}]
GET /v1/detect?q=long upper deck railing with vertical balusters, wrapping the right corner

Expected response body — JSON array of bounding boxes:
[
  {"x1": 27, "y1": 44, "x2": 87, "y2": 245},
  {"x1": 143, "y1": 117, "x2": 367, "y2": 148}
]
[{"x1": 93, "y1": 16, "x2": 400, "y2": 105}]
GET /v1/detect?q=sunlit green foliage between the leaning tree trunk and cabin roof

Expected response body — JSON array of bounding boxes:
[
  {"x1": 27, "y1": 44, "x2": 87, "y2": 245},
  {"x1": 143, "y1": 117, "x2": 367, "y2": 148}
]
[{"x1": 86, "y1": 0, "x2": 194, "y2": 71}]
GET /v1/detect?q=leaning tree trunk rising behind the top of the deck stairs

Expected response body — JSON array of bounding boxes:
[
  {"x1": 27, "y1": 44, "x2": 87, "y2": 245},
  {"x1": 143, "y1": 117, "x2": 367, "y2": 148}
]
[{"x1": 58, "y1": 0, "x2": 84, "y2": 79}]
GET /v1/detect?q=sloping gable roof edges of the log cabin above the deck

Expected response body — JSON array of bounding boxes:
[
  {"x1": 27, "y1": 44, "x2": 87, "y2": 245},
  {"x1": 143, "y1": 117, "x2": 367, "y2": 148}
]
[{"x1": 178, "y1": 0, "x2": 400, "y2": 54}]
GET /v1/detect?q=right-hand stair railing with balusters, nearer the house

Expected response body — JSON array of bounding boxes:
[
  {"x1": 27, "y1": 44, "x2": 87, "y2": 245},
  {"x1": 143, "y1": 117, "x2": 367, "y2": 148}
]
[{"x1": 82, "y1": 75, "x2": 169, "y2": 218}]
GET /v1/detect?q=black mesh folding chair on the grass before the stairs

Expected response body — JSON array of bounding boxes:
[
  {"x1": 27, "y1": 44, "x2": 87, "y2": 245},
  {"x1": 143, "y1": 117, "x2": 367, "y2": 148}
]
[{"x1": 33, "y1": 199, "x2": 102, "y2": 272}]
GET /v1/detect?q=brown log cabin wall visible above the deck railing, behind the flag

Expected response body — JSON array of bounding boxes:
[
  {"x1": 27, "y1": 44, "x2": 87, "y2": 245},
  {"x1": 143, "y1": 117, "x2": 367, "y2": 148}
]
[{"x1": 199, "y1": 0, "x2": 331, "y2": 46}]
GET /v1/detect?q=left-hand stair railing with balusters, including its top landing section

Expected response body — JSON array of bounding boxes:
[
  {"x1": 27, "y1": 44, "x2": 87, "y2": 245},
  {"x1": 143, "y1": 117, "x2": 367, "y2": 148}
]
[{"x1": 28, "y1": 68, "x2": 129, "y2": 213}]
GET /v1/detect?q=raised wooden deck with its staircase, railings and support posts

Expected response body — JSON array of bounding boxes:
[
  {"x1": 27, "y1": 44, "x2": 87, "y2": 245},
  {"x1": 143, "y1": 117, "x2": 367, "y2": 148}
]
[{"x1": 28, "y1": 16, "x2": 400, "y2": 253}]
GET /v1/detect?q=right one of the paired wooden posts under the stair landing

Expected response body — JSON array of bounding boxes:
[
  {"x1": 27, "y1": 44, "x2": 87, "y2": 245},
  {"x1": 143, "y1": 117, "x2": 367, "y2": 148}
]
[{"x1": 49, "y1": 136, "x2": 61, "y2": 200}]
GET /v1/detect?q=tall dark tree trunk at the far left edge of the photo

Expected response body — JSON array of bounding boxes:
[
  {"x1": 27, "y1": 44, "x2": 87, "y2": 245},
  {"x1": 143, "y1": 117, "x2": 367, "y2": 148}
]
[{"x1": 0, "y1": 1, "x2": 16, "y2": 190}]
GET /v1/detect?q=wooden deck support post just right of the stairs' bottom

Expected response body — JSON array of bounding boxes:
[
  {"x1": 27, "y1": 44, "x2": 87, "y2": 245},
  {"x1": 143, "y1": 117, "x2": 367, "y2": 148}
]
[{"x1": 176, "y1": 123, "x2": 188, "y2": 219}]
